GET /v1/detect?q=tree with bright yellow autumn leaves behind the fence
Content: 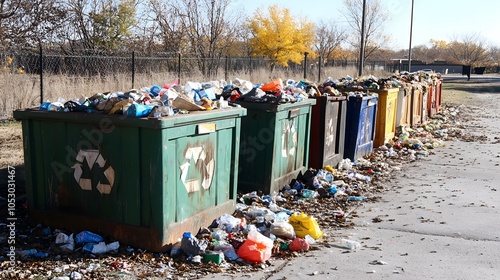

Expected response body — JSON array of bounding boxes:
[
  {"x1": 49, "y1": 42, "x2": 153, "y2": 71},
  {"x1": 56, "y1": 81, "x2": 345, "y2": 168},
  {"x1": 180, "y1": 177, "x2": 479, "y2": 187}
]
[{"x1": 248, "y1": 5, "x2": 315, "y2": 71}]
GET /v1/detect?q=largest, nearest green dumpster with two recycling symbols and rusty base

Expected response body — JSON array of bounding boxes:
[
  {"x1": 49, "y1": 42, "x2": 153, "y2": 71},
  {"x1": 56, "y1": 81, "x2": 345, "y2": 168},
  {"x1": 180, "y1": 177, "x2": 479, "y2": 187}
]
[{"x1": 14, "y1": 108, "x2": 246, "y2": 251}]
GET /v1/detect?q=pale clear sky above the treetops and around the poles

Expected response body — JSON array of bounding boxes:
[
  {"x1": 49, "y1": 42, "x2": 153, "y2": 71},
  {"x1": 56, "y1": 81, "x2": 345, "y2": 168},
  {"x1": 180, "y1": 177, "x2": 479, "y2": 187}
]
[{"x1": 234, "y1": 0, "x2": 500, "y2": 51}]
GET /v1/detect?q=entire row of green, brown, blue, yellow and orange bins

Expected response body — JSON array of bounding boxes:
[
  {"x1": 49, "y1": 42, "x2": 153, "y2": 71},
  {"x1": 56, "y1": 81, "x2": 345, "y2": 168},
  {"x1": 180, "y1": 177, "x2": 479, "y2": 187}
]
[{"x1": 14, "y1": 77, "x2": 437, "y2": 251}]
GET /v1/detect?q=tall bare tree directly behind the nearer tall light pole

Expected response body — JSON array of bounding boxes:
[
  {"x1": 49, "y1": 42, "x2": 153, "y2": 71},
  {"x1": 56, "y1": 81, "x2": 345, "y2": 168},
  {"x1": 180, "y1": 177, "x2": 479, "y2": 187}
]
[{"x1": 343, "y1": 0, "x2": 389, "y2": 61}]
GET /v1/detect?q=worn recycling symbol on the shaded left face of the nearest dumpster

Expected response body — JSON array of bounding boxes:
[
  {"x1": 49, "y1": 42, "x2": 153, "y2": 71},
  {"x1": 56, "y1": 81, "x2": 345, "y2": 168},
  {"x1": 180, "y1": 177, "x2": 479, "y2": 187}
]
[{"x1": 72, "y1": 149, "x2": 115, "y2": 194}]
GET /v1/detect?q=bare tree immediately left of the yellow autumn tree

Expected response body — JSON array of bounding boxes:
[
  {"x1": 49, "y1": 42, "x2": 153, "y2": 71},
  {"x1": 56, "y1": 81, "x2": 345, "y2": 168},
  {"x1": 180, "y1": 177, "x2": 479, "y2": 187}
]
[{"x1": 144, "y1": 0, "x2": 241, "y2": 77}]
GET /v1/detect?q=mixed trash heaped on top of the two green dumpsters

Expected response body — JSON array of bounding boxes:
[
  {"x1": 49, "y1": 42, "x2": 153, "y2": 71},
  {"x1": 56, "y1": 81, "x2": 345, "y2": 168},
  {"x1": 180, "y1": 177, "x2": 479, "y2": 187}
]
[{"x1": 38, "y1": 78, "x2": 328, "y2": 118}]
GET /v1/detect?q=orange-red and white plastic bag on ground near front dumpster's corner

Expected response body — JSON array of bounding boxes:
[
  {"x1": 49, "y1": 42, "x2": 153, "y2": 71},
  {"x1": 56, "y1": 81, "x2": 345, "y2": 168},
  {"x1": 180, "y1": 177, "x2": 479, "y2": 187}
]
[{"x1": 237, "y1": 230, "x2": 273, "y2": 263}]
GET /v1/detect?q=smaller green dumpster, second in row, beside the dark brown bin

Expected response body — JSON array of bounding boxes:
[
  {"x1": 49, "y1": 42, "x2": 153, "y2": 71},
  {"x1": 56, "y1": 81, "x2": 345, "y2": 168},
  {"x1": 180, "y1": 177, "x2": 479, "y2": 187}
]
[{"x1": 237, "y1": 99, "x2": 316, "y2": 194}]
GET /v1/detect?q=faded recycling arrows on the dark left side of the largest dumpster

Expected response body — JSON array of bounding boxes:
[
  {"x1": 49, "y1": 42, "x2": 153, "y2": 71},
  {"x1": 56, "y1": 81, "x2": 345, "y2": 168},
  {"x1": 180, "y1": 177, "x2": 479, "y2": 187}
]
[{"x1": 72, "y1": 150, "x2": 115, "y2": 194}]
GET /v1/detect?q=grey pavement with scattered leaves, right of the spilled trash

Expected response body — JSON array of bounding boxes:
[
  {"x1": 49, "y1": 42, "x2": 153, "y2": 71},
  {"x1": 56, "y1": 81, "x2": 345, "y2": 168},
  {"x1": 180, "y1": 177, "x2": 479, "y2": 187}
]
[{"x1": 203, "y1": 77, "x2": 500, "y2": 280}]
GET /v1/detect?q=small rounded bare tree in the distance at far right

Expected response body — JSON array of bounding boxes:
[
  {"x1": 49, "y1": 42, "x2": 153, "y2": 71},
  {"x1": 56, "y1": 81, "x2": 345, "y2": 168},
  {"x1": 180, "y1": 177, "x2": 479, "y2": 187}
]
[{"x1": 447, "y1": 33, "x2": 488, "y2": 65}]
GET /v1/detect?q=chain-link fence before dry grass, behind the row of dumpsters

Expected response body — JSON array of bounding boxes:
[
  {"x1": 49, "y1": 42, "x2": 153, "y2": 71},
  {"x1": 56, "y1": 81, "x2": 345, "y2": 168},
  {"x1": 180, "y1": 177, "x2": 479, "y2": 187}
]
[{"x1": 0, "y1": 48, "x2": 392, "y2": 117}]
